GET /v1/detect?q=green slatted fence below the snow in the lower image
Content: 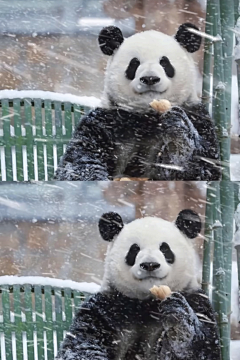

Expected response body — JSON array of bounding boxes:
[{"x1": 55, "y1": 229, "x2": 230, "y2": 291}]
[{"x1": 0, "y1": 284, "x2": 89, "y2": 360}]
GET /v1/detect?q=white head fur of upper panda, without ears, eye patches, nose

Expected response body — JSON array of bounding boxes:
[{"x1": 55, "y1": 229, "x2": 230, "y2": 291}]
[{"x1": 103, "y1": 30, "x2": 199, "y2": 111}]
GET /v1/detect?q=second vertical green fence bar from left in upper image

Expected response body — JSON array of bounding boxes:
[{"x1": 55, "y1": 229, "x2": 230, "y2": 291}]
[{"x1": 13, "y1": 99, "x2": 24, "y2": 181}]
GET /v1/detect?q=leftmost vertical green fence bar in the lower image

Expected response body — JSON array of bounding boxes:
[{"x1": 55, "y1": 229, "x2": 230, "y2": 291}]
[{"x1": 1, "y1": 285, "x2": 13, "y2": 360}]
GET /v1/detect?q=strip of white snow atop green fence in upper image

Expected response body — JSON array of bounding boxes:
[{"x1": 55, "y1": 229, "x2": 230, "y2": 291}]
[{"x1": 0, "y1": 90, "x2": 101, "y2": 108}]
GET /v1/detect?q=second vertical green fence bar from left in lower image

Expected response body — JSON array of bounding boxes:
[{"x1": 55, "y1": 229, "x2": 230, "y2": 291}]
[{"x1": 13, "y1": 285, "x2": 23, "y2": 360}]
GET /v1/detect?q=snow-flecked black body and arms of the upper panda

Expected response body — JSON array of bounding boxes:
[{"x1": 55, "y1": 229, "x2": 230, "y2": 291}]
[{"x1": 55, "y1": 104, "x2": 221, "y2": 181}]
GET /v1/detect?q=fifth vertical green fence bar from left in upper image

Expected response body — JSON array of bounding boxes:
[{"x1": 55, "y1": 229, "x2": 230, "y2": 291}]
[{"x1": 44, "y1": 100, "x2": 54, "y2": 181}]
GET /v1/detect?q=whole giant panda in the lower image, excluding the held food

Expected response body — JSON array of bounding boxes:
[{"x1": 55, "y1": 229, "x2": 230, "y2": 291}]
[{"x1": 58, "y1": 210, "x2": 220, "y2": 360}]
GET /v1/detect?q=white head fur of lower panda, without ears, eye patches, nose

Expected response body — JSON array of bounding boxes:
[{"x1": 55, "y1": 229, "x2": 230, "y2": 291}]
[{"x1": 102, "y1": 217, "x2": 199, "y2": 299}]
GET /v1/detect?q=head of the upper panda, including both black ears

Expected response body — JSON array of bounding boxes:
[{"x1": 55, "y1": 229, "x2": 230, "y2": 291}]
[{"x1": 98, "y1": 23, "x2": 201, "y2": 112}]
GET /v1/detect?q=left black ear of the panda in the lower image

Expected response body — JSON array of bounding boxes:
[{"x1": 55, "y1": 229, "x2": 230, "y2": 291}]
[{"x1": 98, "y1": 212, "x2": 124, "y2": 241}]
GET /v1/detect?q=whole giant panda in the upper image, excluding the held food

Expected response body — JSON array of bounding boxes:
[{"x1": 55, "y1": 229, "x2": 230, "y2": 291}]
[{"x1": 55, "y1": 23, "x2": 220, "y2": 181}]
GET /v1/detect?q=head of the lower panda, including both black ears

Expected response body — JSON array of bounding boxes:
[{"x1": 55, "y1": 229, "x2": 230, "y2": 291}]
[{"x1": 99, "y1": 210, "x2": 201, "y2": 299}]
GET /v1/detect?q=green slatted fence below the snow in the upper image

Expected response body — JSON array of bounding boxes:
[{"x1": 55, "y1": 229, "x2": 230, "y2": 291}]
[{"x1": 0, "y1": 98, "x2": 90, "y2": 181}]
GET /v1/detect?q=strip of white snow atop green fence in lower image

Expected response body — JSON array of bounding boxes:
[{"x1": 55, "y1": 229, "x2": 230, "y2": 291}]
[{"x1": 0, "y1": 275, "x2": 100, "y2": 294}]
